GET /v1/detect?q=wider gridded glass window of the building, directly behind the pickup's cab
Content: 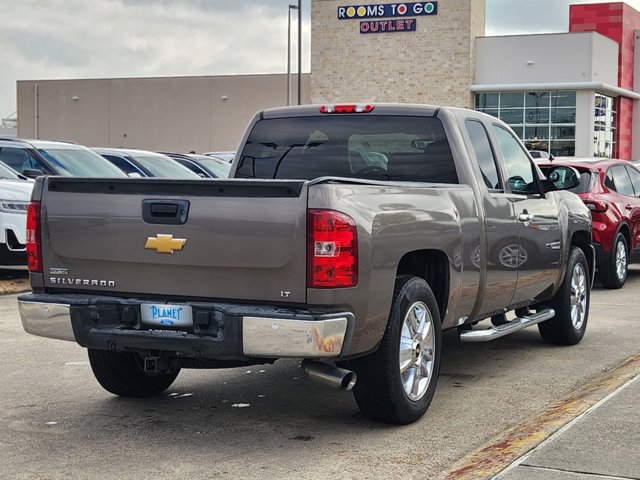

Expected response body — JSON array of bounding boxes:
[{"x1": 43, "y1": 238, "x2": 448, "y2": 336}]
[{"x1": 476, "y1": 91, "x2": 576, "y2": 156}]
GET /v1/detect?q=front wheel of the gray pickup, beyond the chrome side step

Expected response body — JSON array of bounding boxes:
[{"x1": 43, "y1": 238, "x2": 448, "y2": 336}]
[{"x1": 538, "y1": 247, "x2": 591, "y2": 345}]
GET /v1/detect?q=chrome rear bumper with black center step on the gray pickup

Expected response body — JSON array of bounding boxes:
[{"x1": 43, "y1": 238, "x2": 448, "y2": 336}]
[{"x1": 18, "y1": 295, "x2": 353, "y2": 359}]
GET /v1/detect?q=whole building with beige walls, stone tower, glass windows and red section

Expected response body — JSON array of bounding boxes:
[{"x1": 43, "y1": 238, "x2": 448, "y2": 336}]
[{"x1": 17, "y1": 0, "x2": 640, "y2": 159}]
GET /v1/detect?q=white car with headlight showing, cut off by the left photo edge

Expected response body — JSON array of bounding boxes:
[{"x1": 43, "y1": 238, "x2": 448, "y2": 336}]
[{"x1": 0, "y1": 162, "x2": 34, "y2": 269}]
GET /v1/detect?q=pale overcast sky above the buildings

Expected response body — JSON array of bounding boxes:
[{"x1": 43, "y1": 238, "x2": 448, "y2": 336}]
[{"x1": 0, "y1": 0, "x2": 640, "y2": 118}]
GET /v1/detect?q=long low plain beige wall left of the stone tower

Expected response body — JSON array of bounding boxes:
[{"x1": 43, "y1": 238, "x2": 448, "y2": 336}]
[{"x1": 17, "y1": 74, "x2": 310, "y2": 152}]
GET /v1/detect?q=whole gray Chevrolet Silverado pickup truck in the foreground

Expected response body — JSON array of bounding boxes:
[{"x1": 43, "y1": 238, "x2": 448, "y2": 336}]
[{"x1": 18, "y1": 104, "x2": 594, "y2": 424}]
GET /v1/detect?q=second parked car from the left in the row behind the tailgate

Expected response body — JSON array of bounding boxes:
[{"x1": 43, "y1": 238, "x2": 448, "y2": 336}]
[{"x1": 92, "y1": 148, "x2": 200, "y2": 180}]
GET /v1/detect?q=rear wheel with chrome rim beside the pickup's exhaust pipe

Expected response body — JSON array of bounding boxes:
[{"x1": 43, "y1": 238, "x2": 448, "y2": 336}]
[{"x1": 350, "y1": 276, "x2": 441, "y2": 425}]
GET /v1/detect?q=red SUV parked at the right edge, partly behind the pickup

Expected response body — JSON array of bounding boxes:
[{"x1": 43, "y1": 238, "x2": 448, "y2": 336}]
[{"x1": 537, "y1": 157, "x2": 640, "y2": 288}]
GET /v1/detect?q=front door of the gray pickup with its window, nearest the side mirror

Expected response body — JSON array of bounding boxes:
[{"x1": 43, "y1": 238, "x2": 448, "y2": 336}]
[{"x1": 492, "y1": 124, "x2": 563, "y2": 304}]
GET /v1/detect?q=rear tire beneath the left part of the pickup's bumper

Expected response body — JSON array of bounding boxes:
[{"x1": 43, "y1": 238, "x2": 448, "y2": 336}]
[{"x1": 89, "y1": 348, "x2": 179, "y2": 397}]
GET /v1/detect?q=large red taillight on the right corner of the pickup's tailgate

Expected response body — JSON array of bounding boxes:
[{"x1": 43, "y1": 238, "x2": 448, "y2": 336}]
[{"x1": 307, "y1": 210, "x2": 358, "y2": 288}]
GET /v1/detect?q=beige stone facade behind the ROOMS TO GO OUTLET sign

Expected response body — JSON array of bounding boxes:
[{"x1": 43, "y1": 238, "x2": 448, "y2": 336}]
[{"x1": 311, "y1": 0, "x2": 485, "y2": 108}]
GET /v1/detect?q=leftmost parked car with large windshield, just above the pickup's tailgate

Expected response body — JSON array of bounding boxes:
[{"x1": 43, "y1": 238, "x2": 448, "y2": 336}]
[{"x1": 0, "y1": 138, "x2": 125, "y2": 178}]
